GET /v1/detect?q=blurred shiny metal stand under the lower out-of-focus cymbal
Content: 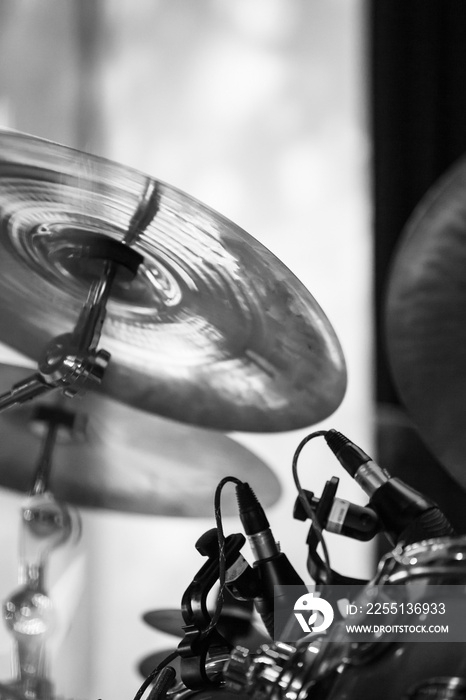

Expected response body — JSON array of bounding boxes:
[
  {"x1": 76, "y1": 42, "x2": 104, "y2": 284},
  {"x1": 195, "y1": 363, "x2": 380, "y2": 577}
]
[{"x1": 0, "y1": 407, "x2": 80, "y2": 700}]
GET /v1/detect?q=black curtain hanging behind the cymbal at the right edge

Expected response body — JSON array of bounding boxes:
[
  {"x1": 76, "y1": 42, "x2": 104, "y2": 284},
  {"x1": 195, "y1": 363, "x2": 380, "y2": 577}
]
[{"x1": 368, "y1": 0, "x2": 466, "y2": 531}]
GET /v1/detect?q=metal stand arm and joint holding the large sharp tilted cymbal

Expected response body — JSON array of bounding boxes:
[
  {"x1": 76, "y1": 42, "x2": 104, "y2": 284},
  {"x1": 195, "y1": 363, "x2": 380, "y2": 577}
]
[{"x1": 0, "y1": 241, "x2": 143, "y2": 413}]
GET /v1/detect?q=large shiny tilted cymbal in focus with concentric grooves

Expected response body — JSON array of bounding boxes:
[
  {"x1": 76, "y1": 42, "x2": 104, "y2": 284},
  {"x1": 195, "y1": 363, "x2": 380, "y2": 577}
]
[{"x1": 0, "y1": 131, "x2": 346, "y2": 432}]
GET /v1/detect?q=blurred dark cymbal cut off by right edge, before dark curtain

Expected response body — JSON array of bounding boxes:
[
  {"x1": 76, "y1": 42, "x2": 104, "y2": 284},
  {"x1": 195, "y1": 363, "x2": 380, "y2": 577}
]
[{"x1": 386, "y1": 160, "x2": 466, "y2": 488}]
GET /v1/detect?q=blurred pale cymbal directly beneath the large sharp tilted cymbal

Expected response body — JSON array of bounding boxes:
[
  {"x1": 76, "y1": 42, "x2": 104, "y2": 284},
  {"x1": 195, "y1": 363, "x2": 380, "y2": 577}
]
[{"x1": 0, "y1": 365, "x2": 280, "y2": 517}]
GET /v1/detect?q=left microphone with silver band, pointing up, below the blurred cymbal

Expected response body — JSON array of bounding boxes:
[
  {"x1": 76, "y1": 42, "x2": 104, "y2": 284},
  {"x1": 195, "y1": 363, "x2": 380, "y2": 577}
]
[{"x1": 236, "y1": 483, "x2": 307, "y2": 639}]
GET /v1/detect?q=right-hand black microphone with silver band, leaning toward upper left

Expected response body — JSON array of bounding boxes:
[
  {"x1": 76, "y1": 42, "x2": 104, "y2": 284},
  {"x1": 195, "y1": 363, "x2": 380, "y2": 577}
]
[{"x1": 325, "y1": 430, "x2": 454, "y2": 545}]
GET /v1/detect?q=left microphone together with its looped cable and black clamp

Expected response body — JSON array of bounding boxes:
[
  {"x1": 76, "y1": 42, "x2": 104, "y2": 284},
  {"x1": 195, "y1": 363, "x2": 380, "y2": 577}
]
[{"x1": 137, "y1": 477, "x2": 306, "y2": 697}]
